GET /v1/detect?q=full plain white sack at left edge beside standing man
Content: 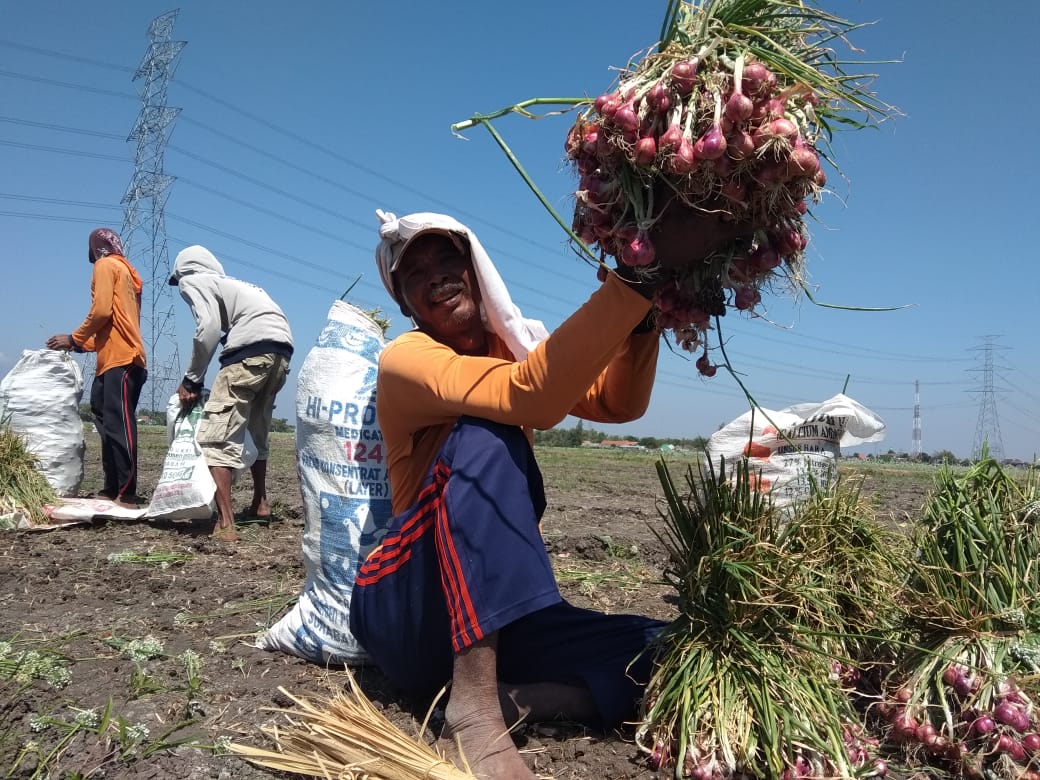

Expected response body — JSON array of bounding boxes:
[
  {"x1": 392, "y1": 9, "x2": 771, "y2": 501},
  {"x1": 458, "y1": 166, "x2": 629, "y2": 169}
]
[{"x1": 0, "y1": 349, "x2": 86, "y2": 496}]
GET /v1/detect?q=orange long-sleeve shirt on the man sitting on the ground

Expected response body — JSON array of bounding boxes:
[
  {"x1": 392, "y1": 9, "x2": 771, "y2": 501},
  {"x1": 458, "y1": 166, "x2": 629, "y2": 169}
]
[{"x1": 375, "y1": 274, "x2": 660, "y2": 514}]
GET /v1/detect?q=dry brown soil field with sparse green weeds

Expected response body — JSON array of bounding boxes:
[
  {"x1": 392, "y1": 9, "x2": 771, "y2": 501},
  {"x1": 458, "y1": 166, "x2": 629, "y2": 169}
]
[{"x1": 0, "y1": 427, "x2": 933, "y2": 780}]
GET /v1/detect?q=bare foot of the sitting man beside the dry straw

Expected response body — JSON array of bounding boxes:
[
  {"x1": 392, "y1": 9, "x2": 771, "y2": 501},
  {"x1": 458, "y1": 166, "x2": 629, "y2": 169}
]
[{"x1": 437, "y1": 704, "x2": 536, "y2": 780}]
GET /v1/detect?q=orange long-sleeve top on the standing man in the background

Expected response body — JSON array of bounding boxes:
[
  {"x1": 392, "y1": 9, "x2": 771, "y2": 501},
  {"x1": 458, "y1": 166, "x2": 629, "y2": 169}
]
[{"x1": 72, "y1": 255, "x2": 148, "y2": 374}]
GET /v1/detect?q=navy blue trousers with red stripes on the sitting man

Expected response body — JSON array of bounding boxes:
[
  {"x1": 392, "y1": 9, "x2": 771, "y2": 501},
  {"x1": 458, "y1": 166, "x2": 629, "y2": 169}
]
[{"x1": 350, "y1": 417, "x2": 665, "y2": 727}]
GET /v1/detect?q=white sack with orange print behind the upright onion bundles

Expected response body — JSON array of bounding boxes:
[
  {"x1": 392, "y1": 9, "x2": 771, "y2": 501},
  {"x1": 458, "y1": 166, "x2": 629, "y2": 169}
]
[{"x1": 707, "y1": 393, "x2": 885, "y2": 506}]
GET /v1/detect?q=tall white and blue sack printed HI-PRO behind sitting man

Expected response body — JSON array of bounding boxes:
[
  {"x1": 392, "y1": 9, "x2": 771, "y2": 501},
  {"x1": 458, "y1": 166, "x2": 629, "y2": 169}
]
[{"x1": 257, "y1": 301, "x2": 391, "y2": 665}]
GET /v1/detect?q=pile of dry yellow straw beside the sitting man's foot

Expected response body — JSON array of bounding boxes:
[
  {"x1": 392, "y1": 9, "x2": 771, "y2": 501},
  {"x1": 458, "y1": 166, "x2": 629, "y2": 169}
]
[{"x1": 229, "y1": 675, "x2": 474, "y2": 780}]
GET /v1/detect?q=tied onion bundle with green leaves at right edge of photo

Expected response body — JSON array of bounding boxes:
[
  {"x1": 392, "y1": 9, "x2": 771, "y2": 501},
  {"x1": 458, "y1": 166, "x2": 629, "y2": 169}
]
[{"x1": 877, "y1": 457, "x2": 1040, "y2": 780}]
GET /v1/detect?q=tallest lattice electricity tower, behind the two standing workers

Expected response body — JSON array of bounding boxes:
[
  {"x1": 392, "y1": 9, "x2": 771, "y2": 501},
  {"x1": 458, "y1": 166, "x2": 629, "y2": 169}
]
[{"x1": 122, "y1": 10, "x2": 187, "y2": 410}]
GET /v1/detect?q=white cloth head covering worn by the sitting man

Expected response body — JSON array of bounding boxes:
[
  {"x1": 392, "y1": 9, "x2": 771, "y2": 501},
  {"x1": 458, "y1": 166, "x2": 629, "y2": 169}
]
[{"x1": 375, "y1": 209, "x2": 549, "y2": 360}]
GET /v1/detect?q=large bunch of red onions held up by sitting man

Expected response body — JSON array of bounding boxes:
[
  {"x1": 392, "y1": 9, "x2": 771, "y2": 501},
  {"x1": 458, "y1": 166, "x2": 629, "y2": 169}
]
[{"x1": 566, "y1": 0, "x2": 893, "y2": 375}]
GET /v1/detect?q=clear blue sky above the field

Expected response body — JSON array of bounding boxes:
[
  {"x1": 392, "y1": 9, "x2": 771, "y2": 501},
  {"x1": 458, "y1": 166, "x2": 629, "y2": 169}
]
[{"x1": 6, "y1": 0, "x2": 1040, "y2": 459}]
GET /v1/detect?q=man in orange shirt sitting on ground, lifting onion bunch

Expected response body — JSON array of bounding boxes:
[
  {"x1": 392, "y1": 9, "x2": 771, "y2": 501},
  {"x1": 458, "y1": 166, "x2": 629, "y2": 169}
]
[{"x1": 350, "y1": 204, "x2": 752, "y2": 780}]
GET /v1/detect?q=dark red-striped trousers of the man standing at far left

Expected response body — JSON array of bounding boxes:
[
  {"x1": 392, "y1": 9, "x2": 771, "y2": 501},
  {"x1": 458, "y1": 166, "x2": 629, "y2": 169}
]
[{"x1": 90, "y1": 364, "x2": 148, "y2": 498}]
